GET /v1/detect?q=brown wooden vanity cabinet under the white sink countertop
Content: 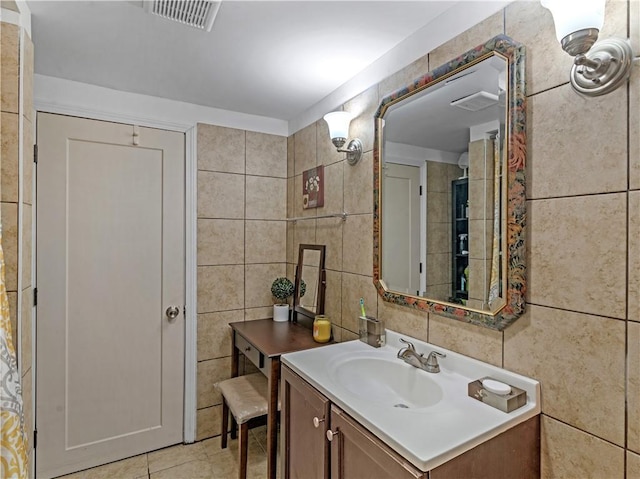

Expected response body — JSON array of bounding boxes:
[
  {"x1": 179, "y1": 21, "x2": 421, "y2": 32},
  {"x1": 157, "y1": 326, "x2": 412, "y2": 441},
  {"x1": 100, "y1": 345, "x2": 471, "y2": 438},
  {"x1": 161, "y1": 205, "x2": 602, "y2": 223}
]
[{"x1": 281, "y1": 366, "x2": 540, "y2": 479}]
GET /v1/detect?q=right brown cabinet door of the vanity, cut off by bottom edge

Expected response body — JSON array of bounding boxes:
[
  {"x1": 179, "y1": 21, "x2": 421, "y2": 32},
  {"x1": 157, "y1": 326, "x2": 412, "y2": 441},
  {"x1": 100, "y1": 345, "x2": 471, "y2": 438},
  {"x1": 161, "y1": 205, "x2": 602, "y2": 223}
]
[{"x1": 331, "y1": 405, "x2": 428, "y2": 479}]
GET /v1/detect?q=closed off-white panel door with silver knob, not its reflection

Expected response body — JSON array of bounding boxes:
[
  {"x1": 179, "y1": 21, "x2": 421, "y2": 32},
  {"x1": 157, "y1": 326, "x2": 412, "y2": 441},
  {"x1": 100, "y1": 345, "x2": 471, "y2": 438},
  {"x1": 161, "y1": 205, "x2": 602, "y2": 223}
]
[{"x1": 36, "y1": 113, "x2": 185, "y2": 478}]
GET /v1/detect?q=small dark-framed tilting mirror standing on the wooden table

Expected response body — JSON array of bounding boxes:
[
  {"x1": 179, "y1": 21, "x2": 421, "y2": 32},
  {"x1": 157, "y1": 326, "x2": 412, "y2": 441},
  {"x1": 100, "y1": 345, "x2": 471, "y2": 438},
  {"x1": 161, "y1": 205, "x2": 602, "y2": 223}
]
[{"x1": 293, "y1": 244, "x2": 326, "y2": 321}]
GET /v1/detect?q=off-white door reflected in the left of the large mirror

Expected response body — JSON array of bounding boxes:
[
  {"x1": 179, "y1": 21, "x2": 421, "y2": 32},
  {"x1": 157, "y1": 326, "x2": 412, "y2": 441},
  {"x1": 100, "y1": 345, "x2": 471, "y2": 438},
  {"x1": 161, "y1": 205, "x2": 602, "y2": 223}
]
[{"x1": 381, "y1": 163, "x2": 420, "y2": 295}]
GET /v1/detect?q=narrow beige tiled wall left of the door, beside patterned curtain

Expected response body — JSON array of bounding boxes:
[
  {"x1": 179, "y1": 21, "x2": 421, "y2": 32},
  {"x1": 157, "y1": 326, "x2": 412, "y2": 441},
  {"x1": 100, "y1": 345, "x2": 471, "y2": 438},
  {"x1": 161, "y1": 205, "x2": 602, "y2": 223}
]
[{"x1": 0, "y1": 18, "x2": 34, "y2": 476}]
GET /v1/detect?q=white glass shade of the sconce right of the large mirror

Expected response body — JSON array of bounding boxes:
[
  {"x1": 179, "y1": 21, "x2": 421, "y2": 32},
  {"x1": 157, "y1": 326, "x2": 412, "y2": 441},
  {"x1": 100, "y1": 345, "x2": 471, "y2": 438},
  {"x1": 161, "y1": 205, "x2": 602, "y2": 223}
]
[{"x1": 540, "y1": 0, "x2": 605, "y2": 42}]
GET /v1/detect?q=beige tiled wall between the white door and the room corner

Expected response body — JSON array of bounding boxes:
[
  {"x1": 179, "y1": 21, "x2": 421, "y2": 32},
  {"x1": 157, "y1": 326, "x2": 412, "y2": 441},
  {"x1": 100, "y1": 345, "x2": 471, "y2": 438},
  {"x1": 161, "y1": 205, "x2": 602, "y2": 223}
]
[{"x1": 197, "y1": 124, "x2": 287, "y2": 439}]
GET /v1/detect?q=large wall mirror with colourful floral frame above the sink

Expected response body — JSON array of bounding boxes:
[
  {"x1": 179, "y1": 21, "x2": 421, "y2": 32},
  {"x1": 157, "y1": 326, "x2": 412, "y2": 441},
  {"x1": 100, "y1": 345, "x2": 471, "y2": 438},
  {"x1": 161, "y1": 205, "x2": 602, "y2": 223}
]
[{"x1": 374, "y1": 35, "x2": 526, "y2": 330}]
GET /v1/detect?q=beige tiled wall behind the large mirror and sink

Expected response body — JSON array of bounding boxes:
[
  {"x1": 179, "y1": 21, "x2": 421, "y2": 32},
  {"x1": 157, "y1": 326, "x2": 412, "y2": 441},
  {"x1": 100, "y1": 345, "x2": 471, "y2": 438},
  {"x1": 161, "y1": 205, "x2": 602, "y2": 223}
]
[{"x1": 287, "y1": 0, "x2": 640, "y2": 478}]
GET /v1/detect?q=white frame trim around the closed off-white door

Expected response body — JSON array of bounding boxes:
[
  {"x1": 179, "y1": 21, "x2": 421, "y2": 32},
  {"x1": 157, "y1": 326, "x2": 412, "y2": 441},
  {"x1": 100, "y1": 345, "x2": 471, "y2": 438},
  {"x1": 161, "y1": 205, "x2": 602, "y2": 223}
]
[{"x1": 33, "y1": 104, "x2": 198, "y2": 442}]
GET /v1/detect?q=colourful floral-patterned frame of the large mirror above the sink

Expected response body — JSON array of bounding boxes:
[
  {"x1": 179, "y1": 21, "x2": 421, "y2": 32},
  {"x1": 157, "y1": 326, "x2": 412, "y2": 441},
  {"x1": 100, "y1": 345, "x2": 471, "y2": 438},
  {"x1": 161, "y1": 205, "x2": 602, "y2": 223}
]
[{"x1": 373, "y1": 35, "x2": 527, "y2": 331}]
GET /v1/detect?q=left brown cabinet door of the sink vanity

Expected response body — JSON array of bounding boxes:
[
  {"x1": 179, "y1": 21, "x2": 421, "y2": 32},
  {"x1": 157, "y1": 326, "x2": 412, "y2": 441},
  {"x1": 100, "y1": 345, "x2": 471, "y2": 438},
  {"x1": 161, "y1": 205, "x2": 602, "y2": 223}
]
[{"x1": 281, "y1": 366, "x2": 329, "y2": 479}]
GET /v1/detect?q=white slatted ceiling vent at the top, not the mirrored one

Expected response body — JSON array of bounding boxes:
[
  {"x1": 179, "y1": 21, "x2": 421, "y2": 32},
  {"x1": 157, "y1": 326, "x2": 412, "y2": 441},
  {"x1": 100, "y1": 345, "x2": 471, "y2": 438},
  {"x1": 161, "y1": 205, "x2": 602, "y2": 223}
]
[{"x1": 144, "y1": 0, "x2": 221, "y2": 32}]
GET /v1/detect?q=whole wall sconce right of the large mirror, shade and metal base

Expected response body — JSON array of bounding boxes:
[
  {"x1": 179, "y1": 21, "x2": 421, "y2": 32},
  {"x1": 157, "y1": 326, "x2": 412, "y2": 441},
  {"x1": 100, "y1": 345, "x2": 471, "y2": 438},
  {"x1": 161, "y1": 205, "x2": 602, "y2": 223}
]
[{"x1": 540, "y1": 0, "x2": 633, "y2": 96}]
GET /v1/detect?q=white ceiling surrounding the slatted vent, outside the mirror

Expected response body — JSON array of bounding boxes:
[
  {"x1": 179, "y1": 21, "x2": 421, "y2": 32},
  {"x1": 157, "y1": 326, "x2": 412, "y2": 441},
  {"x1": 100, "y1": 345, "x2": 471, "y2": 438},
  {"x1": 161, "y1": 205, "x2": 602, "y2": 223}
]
[{"x1": 28, "y1": 0, "x2": 460, "y2": 121}]
